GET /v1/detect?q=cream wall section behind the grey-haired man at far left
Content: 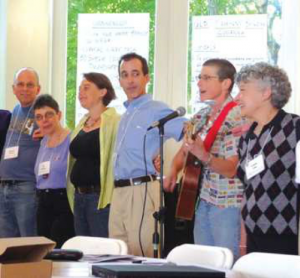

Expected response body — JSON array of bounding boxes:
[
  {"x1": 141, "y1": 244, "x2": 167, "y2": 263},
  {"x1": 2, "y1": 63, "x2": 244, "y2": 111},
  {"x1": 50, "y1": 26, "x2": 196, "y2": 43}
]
[{"x1": 0, "y1": 0, "x2": 51, "y2": 109}]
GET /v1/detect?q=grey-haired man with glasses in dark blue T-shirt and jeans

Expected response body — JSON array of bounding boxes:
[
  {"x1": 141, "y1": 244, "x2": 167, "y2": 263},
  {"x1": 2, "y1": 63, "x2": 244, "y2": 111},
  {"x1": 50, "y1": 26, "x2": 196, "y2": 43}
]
[{"x1": 0, "y1": 68, "x2": 40, "y2": 237}]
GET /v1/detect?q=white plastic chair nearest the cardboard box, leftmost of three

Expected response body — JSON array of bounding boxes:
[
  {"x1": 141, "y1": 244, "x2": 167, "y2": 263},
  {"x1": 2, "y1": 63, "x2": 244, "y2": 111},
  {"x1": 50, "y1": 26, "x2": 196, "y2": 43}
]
[{"x1": 62, "y1": 236, "x2": 128, "y2": 255}]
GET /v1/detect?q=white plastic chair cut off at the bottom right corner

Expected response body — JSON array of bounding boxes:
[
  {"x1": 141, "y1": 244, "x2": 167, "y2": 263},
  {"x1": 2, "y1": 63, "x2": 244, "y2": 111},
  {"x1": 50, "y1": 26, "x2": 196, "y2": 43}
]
[{"x1": 232, "y1": 253, "x2": 300, "y2": 278}]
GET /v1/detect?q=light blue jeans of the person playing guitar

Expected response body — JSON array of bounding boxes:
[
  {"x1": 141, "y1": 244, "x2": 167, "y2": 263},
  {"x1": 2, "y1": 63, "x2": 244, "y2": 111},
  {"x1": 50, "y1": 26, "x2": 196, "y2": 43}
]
[{"x1": 194, "y1": 200, "x2": 241, "y2": 260}]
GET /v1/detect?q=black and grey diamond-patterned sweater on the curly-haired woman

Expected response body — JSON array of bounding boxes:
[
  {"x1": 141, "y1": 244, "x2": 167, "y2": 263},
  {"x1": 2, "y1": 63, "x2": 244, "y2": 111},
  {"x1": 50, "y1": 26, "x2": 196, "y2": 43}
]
[{"x1": 237, "y1": 110, "x2": 300, "y2": 235}]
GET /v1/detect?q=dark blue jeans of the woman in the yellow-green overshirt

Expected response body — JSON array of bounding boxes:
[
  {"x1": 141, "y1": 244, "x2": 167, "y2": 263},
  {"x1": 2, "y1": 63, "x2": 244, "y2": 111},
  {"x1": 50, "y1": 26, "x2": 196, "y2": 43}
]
[{"x1": 74, "y1": 193, "x2": 109, "y2": 237}]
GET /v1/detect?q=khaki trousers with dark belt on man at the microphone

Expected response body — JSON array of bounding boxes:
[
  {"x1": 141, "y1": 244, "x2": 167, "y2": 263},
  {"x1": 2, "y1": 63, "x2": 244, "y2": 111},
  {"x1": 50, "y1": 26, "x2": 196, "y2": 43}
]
[{"x1": 109, "y1": 181, "x2": 160, "y2": 257}]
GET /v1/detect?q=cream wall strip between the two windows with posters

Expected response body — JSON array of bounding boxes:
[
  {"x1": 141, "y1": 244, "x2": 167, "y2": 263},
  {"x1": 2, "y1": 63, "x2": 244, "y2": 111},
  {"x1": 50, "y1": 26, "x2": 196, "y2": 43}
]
[{"x1": 154, "y1": 0, "x2": 189, "y2": 169}]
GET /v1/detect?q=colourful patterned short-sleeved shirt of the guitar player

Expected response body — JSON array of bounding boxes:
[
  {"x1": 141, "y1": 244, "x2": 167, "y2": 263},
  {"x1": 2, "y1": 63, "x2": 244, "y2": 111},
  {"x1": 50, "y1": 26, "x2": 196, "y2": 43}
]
[{"x1": 200, "y1": 97, "x2": 243, "y2": 208}]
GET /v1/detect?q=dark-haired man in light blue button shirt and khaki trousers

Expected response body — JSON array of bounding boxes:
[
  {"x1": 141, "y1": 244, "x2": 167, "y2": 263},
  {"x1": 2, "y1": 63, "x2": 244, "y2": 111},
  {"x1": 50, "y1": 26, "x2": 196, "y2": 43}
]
[{"x1": 109, "y1": 53, "x2": 185, "y2": 257}]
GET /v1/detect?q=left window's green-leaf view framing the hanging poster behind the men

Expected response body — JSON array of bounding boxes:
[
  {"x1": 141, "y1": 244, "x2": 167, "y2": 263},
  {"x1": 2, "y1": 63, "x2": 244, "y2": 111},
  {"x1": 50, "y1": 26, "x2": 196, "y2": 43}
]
[{"x1": 66, "y1": 0, "x2": 155, "y2": 129}]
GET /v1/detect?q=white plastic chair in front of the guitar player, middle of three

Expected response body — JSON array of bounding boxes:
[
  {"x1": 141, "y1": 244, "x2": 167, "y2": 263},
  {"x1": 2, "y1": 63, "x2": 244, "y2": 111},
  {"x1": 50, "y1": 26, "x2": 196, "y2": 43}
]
[{"x1": 167, "y1": 244, "x2": 233, "y2": 269}]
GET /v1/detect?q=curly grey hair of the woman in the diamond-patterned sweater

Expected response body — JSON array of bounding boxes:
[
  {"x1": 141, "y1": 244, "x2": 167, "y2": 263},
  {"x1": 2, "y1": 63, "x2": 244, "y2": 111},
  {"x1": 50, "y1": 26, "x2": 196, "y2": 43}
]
[{"x1": 236, "y1": 62, "x2": 292, "y2": 109}]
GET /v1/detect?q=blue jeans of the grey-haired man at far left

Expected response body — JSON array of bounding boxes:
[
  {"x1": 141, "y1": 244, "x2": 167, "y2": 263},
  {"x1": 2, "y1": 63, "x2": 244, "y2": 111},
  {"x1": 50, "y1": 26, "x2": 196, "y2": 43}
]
[{"x1": 0, "y1": 181, "x2": 37, "y2": 238}]
